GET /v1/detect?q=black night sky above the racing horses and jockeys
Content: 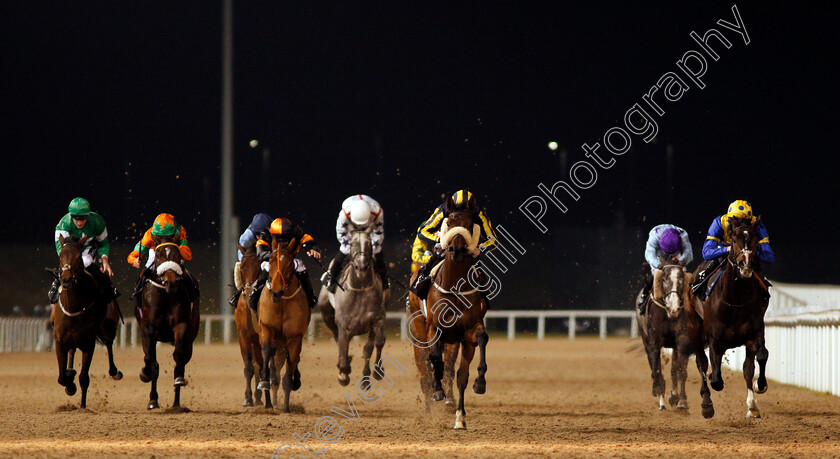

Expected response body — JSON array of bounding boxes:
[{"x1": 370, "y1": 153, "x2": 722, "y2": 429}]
[{"x1": 0, "y1": 1, "x2": 840, "y2": 298}]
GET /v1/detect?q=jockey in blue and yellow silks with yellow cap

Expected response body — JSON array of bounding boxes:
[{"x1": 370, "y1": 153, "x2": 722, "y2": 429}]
[{"x1": 691, "y1": 200, "x2": 776, "y2": 300}]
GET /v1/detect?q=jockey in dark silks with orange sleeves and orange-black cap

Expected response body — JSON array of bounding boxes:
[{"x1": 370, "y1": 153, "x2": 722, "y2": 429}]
[{"x1": 248, "y1": 218, "x2": 321, "y2": 311}]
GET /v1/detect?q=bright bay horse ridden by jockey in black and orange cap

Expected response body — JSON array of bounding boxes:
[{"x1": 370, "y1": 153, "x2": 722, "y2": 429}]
[{"x1": 256, "y1": 238, "x2": 310, "y2": 413}]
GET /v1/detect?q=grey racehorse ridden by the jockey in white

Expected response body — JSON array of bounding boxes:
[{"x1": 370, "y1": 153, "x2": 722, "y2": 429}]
[{"x1": 318, "y1": 231, "x2": 385, "y2": 386}]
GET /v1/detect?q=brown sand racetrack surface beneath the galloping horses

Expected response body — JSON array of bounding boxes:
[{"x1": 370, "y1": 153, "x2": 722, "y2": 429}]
[{"x1": 0, "y1": 336, "x2": 840, "y2": 458}]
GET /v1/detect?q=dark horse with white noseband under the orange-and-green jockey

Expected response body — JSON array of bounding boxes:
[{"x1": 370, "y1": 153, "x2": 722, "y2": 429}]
[{"x1": 134, "y1": 236, "x2": 200, "y2": 410}]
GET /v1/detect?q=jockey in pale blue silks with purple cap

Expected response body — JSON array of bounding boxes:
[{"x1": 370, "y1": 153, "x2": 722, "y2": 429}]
[{"x1": 636, "y1": 224, "x2": 694, "y2": 314}]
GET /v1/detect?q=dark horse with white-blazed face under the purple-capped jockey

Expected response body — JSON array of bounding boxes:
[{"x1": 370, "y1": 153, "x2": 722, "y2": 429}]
[{"x1": 636, "y1": 260, "x2": 705, "y2": 411}]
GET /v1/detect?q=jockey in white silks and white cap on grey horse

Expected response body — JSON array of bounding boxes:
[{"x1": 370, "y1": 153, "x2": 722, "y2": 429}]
[{"x1": 327, "y1": 194, "x2": 388, "y2": 293}]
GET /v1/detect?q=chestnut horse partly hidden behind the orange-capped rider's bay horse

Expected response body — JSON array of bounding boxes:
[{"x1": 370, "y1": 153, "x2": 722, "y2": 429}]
[{"x1": 234, "y1": 245, "x2": 280, "y2": 406}]
